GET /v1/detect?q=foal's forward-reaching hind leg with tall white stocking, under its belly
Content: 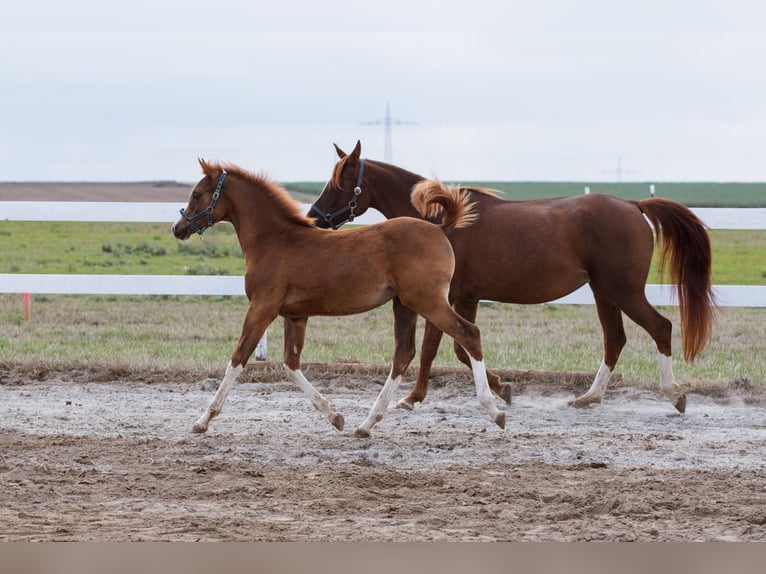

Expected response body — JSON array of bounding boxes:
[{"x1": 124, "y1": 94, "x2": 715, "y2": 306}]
[{"x1": 354, "y1": 297, "x2": 418, "y2": 438}]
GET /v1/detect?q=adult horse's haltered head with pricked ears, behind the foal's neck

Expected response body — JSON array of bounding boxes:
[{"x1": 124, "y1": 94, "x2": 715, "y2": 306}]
[{"x1": 306, "y1": 141, "x2": 370, "y2": 229}]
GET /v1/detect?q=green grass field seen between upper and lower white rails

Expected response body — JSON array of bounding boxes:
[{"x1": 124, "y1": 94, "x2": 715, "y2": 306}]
[{"x1": 0, "y1": 221, "x2": 766, "y2": 285}]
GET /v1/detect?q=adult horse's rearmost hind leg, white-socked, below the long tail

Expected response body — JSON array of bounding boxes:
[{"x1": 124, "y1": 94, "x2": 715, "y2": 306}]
[{"x1": 622, "y1": 291, "x2": 686, "y2": 413}]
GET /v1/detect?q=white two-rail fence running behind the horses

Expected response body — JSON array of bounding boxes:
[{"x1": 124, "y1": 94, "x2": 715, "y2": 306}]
[{"x1": 0, "y1": 201, "x2": 766, "y2": 307}]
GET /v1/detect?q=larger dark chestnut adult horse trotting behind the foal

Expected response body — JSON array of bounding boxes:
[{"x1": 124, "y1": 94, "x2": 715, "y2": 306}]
[{"x1": 308, "y1": 142, "x2": 715, "y2": 412}]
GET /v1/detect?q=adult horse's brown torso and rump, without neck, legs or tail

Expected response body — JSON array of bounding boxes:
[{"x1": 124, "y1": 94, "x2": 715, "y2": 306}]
[{"x1": 450, "y1": 194, "x2": 653, "y2": 303}]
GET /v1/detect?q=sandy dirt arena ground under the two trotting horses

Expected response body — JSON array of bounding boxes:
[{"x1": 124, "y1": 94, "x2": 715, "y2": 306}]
[{"x1": 0, "y1": 366, "x2": 766, "y2": 541}]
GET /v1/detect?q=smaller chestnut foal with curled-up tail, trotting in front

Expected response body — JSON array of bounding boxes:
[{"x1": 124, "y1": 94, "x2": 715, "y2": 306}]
[{"x1": 172, "y1": 160, "x2": 505, "y2": 437}]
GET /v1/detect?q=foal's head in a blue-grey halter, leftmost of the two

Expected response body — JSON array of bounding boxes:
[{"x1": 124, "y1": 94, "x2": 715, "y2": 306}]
[{"x1": 172, "y1": 159, "x2": 231, "y2": 239}]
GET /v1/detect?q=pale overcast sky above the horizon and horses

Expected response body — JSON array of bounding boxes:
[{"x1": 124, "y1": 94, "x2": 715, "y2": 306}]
[{"x1": 0, "y1": 0, "x2": 766, "y2": 182}]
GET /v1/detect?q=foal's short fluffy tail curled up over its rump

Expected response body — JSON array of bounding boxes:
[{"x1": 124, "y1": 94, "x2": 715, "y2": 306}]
[{"x1": 410, "y1": 179, "x2": 478, "y2": 230}]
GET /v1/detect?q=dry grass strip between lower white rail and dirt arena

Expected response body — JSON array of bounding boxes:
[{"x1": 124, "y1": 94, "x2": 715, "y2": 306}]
[{"x1": 0, "y1": 295, "x2": 766, "y2": 391}]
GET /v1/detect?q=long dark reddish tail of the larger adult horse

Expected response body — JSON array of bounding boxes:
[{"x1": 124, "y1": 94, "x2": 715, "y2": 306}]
[{"x1": 634, "y1": 198, "x2": 716, "y2": 361}]
